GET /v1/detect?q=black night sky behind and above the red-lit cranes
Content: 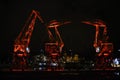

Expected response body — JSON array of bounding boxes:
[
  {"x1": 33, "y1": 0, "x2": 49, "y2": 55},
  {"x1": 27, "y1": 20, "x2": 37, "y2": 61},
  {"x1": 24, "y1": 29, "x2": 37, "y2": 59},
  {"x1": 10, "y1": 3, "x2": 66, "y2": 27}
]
[{"x1": 0, "y1": 0, "x2": 120, "y2": 60}]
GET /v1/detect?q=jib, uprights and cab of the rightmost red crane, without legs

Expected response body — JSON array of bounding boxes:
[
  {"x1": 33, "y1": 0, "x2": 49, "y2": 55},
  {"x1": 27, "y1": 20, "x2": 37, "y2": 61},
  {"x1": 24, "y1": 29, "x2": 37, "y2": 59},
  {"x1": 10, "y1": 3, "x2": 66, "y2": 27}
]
[{"x1": 82, "y1": 19, "x2": 113, "y2": 56}]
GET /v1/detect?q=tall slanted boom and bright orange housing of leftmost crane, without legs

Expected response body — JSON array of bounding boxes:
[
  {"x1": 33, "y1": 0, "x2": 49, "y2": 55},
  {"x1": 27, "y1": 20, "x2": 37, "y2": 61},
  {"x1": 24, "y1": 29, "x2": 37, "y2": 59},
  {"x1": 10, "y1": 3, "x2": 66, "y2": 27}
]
[{"x1": 14, "y1": 10, "x2": 43, "y2": 52}]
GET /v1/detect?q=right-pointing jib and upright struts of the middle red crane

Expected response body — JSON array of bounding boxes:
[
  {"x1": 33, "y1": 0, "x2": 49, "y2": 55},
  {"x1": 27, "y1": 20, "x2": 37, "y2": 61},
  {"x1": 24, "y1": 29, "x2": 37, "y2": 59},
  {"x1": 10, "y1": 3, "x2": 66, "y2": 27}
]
[{"x1": 47, "y1": 20, "x2": 71, "y2": 53}]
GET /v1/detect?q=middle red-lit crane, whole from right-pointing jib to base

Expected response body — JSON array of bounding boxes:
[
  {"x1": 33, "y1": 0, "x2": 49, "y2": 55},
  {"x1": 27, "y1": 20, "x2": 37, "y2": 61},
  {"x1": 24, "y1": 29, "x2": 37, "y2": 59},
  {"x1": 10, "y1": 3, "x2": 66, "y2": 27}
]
[{"x1": 45, "y1": 20, "x2": 70, "y2": 70}]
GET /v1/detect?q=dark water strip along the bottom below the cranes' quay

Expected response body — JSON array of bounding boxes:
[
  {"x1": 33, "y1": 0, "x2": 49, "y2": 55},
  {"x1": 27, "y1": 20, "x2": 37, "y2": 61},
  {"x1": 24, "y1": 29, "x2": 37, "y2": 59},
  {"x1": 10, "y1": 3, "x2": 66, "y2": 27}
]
[{"x1": 0, "y1": 70, "x2": 120, "y2": 80}]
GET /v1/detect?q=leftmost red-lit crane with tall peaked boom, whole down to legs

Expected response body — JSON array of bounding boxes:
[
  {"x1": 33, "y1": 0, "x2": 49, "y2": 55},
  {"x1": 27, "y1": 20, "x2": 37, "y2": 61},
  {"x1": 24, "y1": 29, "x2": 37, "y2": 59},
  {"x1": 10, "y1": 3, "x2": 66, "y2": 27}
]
[{"x1": 13, "y1": 10, "x2": 43, "y2": 66}]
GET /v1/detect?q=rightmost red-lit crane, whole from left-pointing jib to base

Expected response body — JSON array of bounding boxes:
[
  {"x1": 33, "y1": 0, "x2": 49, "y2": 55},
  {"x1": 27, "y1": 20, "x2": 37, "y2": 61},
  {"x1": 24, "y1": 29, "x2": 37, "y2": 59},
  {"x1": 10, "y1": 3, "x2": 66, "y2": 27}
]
[{"x1": 82, "y1": 19, "x2": 113, "y2": 66}]
